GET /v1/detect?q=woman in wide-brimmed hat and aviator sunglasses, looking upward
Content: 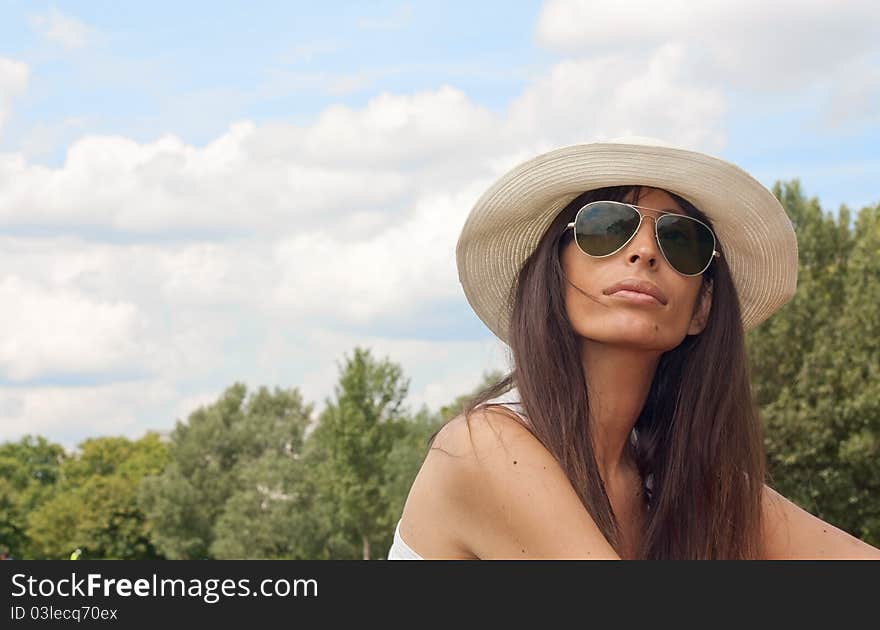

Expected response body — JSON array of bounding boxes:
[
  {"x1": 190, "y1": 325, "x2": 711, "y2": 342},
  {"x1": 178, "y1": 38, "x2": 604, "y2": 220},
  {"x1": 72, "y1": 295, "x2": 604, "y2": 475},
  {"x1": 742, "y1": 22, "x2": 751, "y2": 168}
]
[{"x1": 389, "y1": 138, "x2": 880, "y2": 559}]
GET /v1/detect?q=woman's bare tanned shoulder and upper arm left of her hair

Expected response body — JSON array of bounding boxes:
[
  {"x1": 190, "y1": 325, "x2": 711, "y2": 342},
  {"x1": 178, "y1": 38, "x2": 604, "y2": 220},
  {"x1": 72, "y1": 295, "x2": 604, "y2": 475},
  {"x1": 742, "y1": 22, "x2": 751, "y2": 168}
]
[{"x1": 410, "y1": 407, "x2": 618, "y2": 559}]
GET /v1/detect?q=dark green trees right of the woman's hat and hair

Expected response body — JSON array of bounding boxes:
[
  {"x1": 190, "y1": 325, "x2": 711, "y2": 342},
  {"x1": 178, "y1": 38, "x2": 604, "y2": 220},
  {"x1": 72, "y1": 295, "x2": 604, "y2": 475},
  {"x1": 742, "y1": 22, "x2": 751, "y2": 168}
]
[{"x1": 749, "y1": 181, "x2": 880, "y2": 546}]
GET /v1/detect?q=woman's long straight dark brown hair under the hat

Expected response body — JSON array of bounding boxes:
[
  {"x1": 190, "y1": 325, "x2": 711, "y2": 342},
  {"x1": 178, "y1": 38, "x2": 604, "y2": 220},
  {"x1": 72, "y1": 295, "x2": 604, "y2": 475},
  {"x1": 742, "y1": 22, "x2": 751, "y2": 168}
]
[{"x1": 428, "y1": 186, "x2": 766, "y2": 559}]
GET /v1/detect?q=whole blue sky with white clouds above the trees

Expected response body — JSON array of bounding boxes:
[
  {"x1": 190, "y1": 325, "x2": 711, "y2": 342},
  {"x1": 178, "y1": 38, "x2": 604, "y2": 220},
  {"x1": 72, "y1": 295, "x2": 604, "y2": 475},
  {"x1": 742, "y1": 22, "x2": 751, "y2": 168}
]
[{"x1": 0, "y1": 0, "x2": 880, "y2": 447}]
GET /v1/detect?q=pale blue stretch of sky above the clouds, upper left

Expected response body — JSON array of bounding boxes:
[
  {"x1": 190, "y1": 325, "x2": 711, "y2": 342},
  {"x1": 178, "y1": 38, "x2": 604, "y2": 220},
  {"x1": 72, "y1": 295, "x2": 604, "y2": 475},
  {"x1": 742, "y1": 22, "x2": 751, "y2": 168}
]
[{"x1": 0, "y1": 2, "x2": 551, "y2": 156}]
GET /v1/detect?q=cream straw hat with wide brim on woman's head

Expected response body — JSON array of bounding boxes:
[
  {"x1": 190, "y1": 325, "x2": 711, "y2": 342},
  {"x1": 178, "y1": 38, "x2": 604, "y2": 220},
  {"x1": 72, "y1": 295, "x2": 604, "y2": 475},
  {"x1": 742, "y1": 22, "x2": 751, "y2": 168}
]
[{"x1": 456, "y1": 136, "x2": 798, "y2": 342}]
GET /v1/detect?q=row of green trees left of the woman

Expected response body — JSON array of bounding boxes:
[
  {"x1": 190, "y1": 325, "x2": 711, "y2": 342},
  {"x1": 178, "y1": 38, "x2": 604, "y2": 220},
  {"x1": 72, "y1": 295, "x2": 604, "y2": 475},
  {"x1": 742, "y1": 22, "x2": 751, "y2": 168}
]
[{"x1": 0, "y1": 348, "x2": 484, "y2": 559}]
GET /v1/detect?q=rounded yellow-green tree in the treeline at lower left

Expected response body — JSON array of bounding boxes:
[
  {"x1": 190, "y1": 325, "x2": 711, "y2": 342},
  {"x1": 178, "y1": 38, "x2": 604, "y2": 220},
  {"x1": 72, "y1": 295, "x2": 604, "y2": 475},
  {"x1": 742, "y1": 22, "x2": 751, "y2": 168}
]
[{"x1": 28, "y1": 433, "x2": 167, "y2": 560}]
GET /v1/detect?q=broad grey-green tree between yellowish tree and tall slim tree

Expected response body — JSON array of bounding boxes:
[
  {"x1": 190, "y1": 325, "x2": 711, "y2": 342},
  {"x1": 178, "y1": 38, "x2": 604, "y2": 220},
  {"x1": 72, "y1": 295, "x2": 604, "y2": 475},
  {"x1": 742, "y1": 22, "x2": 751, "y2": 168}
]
[{"x1": 140, "y1": 383, "x2": 311, "y2": 559}]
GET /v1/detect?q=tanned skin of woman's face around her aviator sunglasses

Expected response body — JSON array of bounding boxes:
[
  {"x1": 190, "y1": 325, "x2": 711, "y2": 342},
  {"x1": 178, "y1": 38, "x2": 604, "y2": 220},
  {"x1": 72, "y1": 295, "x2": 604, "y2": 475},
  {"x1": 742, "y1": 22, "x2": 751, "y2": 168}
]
[{"x1": 561, "y1": 188, "x2": 711, "y2": 352}]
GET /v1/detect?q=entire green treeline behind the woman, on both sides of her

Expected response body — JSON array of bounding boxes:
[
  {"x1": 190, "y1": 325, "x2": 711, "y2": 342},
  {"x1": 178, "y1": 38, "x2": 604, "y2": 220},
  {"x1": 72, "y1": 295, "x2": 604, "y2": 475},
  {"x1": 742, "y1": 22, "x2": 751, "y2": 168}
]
[{"x1": 0, "y1": 180, "x2": 880, "y2": 559}]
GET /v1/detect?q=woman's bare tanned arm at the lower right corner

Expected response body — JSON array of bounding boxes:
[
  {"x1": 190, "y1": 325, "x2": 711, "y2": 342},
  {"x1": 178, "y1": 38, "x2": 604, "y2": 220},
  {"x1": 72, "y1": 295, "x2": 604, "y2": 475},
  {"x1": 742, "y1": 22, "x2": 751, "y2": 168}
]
[{"x1": 764, "y1": 485, "x2": 880, "y2": 560}]
